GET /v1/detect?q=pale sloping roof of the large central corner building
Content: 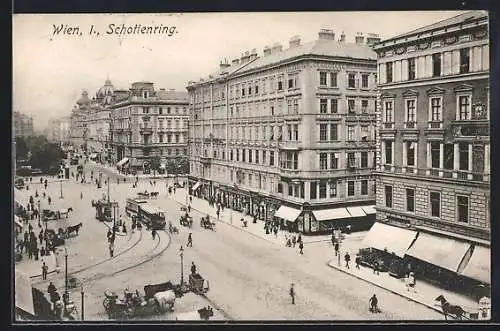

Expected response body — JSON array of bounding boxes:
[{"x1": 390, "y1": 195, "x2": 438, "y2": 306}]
[{"x1": 240, "y1": 39, "x2": 377, "y2": 72}]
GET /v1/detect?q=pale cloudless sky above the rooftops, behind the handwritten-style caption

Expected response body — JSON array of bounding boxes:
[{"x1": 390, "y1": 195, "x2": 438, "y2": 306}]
[{"x1": 12, "y1": 11, "x2": 468, "y2": 129}]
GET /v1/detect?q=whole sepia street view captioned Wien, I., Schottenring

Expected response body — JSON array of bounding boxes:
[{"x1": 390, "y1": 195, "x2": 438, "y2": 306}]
[{"x1": 11, "y1": 10, "x2": 491, "y2": 324}]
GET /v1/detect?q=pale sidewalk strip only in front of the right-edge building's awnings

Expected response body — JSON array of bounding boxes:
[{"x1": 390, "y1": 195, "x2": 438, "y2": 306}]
[{"x1": 327, "y1": 258, "x2": 479, "y2": 318}]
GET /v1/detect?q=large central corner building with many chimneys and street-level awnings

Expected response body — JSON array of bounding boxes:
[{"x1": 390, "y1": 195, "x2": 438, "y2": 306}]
[{"x1": 187, "y1": 30, "x2": 380, "y2": 232}]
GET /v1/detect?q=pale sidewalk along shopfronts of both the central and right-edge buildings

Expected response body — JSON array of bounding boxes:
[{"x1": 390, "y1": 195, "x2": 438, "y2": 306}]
[{"x1": 172, "y1": 189, "x2": 479, "y2": 320}]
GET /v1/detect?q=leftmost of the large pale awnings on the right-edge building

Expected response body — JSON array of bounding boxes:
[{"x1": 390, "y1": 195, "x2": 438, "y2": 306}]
[{"x1": 363, "y1": 222, "x2": 417, "y2": 257}]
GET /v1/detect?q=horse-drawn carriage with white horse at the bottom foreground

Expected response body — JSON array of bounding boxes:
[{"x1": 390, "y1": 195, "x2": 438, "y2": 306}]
[{"x1": 103, "y1": 290, "x2": 176, "y2": 319}]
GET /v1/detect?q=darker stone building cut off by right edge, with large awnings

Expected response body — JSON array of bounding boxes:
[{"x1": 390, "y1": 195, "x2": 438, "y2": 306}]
[{"x1": 372, "y1": 12, "x2": 490, "y2": 286}]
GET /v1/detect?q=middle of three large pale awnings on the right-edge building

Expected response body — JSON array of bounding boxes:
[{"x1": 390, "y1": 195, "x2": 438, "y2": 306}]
[{"x1": 406, "y1": 232, "x2": 470, "y2": 272}]
